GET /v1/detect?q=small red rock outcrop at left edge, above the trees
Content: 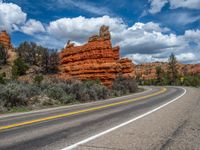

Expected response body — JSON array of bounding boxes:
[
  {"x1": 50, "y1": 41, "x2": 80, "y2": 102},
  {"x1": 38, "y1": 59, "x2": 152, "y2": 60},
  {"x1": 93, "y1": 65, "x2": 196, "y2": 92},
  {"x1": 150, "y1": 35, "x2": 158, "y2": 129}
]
[{"x1": 0, "y1": 31, "x2": 12, "y2": 48}]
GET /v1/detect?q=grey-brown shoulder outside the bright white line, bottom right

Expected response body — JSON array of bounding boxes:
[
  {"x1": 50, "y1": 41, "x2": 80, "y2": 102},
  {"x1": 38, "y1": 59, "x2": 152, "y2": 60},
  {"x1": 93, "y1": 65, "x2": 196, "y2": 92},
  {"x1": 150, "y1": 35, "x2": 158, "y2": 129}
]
[{"x1": 76, "y1": 87, "x2": 200, "y2": 150}]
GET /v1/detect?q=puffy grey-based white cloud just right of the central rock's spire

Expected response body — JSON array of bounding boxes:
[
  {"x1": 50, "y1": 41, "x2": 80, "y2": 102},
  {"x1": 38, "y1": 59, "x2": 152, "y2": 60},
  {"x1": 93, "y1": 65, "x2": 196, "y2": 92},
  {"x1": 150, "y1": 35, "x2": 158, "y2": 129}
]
[{"x1": 118, "y1": 22, "x2": 178, "y2": 55}]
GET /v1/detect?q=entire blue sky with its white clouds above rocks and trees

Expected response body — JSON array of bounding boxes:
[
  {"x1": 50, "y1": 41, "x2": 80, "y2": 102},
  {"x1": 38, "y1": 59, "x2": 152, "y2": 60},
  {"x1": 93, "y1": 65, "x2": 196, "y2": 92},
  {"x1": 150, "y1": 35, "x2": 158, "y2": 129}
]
[{"x1": 0, "y1": 0, "x2": 200, "y2": 63}]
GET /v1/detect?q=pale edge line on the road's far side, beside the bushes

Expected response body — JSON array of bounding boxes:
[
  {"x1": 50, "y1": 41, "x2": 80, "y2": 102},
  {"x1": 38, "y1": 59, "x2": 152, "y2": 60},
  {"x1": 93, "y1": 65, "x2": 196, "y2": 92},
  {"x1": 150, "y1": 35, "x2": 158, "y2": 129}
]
[{"x1": 0, "y1": 87, "x2": 152, "y2": 119}]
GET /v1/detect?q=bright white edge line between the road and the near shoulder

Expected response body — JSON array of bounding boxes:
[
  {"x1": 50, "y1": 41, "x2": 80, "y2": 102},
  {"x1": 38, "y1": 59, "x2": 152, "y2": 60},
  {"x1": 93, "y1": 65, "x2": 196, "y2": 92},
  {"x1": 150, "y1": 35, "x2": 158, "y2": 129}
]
[{"x1": 62, "y1": 87, "x2": 186, "y2": 150}]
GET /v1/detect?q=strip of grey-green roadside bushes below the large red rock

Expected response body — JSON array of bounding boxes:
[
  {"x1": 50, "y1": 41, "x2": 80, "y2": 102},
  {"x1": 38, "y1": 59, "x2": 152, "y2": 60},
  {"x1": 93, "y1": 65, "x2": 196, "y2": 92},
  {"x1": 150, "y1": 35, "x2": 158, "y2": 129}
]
[{"x1": 0, "y1": 75, "x2": 138, "y2": 113}]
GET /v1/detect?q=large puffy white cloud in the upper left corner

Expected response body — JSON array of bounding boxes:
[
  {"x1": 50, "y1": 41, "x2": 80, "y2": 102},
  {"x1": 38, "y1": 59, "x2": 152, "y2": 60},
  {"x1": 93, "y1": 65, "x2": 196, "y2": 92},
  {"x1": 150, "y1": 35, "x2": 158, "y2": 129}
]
[{"x1": 0, "y1": 2, "x2": 27, "y2": 32}]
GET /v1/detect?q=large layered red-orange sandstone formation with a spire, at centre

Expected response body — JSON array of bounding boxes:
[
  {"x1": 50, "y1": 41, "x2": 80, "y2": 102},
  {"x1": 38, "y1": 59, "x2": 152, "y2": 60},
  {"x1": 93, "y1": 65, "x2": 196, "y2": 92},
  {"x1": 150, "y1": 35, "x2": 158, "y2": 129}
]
[{"x1": 59, "y1": 26, "x2": 135, "y2": 86}]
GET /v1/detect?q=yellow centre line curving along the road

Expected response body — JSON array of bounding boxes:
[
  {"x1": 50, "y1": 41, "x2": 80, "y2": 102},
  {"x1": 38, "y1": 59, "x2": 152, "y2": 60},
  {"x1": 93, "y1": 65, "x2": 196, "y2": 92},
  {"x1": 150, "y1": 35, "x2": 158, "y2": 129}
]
[{"x1": 0, "y1": 88, "x2": 167, "y2": 131}]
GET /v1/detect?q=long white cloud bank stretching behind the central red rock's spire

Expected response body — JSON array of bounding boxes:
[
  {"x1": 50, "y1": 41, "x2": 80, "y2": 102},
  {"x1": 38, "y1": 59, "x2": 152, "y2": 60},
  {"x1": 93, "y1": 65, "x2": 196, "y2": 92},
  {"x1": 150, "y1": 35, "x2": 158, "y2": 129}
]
[{"x1": 43, "y1": 16, "x2": 176, "y2": 55}]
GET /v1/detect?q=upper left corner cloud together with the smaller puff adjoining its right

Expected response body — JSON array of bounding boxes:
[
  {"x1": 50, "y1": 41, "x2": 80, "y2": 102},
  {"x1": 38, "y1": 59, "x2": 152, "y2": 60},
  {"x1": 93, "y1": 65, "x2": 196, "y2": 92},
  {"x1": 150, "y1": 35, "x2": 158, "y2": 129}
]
[{"x1": 0, "y1": 1, "x2": 45, "y2": 36}]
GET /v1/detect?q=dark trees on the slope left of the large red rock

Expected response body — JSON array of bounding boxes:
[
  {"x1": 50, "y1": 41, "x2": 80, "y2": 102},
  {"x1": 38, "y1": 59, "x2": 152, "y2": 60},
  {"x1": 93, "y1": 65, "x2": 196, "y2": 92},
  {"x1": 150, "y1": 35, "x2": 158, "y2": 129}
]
[{"x1": 0, "y1": 41, "x2": 59, "y2": 78}]
